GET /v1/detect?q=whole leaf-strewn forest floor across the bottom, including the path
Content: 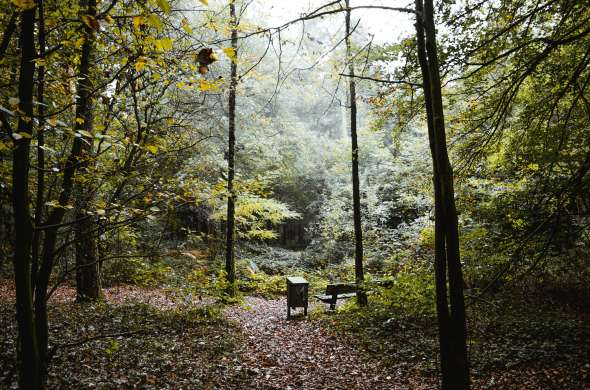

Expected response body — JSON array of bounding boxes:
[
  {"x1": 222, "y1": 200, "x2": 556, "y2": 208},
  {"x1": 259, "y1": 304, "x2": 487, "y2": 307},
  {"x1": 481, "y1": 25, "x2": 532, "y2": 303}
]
[{"x1": 0, "y1": 280, "x2": 590, "y2": 389}]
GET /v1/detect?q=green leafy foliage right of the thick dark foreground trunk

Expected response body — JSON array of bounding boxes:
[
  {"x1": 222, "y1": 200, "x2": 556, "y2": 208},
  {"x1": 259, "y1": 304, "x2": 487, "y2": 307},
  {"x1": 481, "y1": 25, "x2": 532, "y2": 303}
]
[{"x1": 445, "y1": 0, "x2": 590, "y2": 290}]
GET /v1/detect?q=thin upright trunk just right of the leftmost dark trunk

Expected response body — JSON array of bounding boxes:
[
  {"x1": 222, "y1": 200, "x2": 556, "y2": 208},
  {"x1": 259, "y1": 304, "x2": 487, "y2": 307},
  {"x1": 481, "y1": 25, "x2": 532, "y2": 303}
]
[{"x1": 31, "y1": 0, "x2": 45, "y2": 289}]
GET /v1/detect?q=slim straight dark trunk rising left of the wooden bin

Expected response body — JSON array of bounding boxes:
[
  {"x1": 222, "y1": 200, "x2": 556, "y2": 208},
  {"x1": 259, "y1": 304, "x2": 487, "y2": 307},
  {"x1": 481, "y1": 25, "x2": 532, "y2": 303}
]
[{"x1": 225, "y1": 0, "x2": 238, "y2": 295}]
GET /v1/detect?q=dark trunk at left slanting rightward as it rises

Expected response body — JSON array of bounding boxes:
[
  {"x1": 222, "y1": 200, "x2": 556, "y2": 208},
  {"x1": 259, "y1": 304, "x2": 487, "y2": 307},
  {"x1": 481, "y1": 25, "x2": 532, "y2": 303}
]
[{"x1": 35, "y1": 0, "x2": 96, "y2": 373}]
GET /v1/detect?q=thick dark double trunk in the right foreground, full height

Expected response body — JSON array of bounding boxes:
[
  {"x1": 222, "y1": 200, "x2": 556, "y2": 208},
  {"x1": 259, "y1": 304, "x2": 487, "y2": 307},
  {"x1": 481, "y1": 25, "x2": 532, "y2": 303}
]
[{"x1": 416, "y1": 0, "x2": 469, "y2": 390}]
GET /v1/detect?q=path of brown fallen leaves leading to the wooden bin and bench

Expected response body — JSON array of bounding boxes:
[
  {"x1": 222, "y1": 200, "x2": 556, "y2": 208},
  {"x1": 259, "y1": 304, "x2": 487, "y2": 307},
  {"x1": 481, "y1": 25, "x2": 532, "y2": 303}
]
[{"x1": 226, "y1": 297, "x2": 433, "y2": 389}]
